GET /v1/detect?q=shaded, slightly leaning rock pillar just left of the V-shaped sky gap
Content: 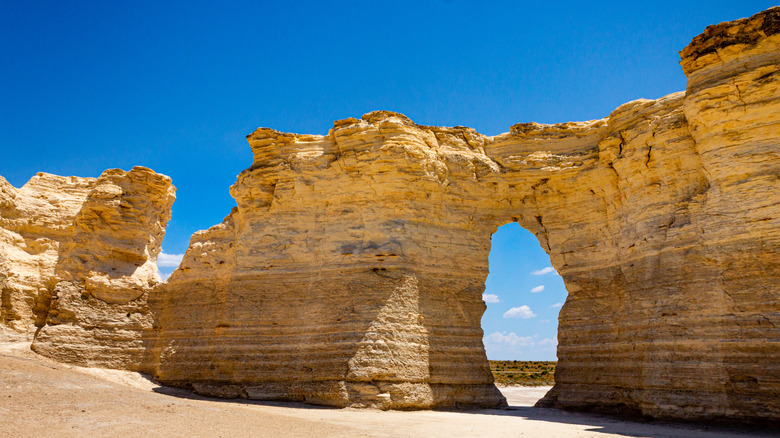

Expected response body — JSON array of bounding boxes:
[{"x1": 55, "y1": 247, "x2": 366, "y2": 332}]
[{"x1": 32, "y1": 167, "x2": 175, "y2": 370}]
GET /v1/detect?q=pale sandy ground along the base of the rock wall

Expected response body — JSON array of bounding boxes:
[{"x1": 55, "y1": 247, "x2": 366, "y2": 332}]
[{"x1": 0, "y1": 343, "x2": 777, "y2": 438}]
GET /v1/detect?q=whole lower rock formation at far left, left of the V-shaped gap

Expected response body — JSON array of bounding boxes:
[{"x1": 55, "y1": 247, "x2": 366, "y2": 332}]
[{"x1": 0, "y1": 167, "x2": 174, "y2": 369}]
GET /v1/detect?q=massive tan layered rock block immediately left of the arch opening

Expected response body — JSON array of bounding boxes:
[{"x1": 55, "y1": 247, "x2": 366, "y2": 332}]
[{"x1": 150, "y1": 112, "x2": 504, "y2": 409}]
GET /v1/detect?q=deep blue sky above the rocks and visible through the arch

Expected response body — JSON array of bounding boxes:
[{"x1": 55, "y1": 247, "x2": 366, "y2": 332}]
[{"x1": 0, "y1": 0, "x2": 774, "y2": 359}]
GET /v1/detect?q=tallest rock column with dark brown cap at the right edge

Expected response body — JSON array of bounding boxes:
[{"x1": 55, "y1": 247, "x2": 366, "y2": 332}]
[{"x1": 680, "y1": 7, "x2": 780, "y2": 419}]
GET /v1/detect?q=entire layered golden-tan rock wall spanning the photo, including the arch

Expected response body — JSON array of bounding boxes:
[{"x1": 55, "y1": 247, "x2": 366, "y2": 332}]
[{"x1": 0, "y1": 8, "x2": 780, "y2": 421}]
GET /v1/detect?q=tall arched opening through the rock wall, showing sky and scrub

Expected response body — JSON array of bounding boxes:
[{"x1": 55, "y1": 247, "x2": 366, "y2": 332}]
[{"x1": 481, "y1": 222, "x2": 568, "y2": 387}]
